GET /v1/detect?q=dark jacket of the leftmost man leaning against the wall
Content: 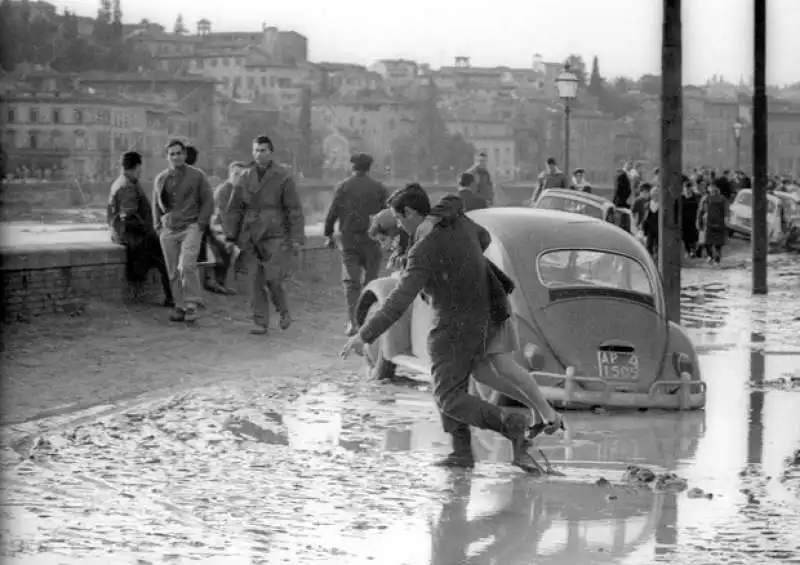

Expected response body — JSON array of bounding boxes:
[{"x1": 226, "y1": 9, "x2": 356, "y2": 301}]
[{"x1": 106, "y1": 173, "x2": 154, "y2": 246}]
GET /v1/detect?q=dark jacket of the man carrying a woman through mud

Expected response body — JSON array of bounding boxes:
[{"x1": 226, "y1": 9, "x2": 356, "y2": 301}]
[{"x1": 360, "y1": 198, "x2": 490, "y2": 356}]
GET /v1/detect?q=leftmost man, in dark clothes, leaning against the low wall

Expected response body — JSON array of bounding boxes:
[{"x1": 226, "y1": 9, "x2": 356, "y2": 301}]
[{"x1": 107, "y1": 151, "x2": 174, "y2": 307}]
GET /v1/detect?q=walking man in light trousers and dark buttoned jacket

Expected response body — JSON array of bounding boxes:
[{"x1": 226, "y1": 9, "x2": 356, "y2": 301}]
[{"x1": 152, "y1": 139, "x2": 214, "y2": 323}]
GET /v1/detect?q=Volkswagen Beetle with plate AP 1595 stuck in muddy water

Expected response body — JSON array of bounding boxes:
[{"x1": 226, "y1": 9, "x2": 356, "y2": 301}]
[{"x1": 357, "y1": 208, "x2": 706, "y2": 409}]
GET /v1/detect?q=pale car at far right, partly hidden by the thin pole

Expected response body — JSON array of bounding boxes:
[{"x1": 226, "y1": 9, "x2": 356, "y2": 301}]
[{"x1": 726, "y1": 188, "x2": 800, "y2": 245}]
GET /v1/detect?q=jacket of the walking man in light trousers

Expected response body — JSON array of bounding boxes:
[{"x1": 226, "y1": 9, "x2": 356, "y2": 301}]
[{"x1": 152, "y1": 165, "x2": 214, "y2": 231}]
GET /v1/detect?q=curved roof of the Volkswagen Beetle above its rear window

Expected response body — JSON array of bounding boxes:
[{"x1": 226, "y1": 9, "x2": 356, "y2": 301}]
[{"x1": 468, "y1": 207, "x2": 647, "y2": 261}]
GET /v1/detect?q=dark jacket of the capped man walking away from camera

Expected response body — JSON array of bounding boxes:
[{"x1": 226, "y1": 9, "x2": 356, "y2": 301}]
[{"x1": 324, "y1": 173, "x2": 389, "y2": 247}]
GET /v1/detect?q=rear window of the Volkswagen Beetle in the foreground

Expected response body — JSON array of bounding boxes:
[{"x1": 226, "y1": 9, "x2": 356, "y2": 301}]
[{"x1": 537, "y1": 249, "x2": 654, "y2": 296}]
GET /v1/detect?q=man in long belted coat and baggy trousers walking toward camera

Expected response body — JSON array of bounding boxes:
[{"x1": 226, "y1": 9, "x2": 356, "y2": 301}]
[{"x1": 225, "y1": 135, "x2": 305, "y2": 335}]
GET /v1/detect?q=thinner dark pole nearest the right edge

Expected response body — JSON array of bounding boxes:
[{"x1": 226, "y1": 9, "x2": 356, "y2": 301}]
[{"x1": 751, "y1": 0, "x2": 768, "y2": 294}]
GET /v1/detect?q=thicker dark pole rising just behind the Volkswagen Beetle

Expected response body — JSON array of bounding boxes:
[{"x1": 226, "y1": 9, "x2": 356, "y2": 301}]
[{"x1": 658, "y1": 0, "x2": 683, "y2": 323}]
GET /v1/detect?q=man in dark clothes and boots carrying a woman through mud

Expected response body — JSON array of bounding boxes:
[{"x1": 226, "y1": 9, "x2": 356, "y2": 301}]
[{"x1": 341, "y1": 185, "x2": 539, "y2": 473}]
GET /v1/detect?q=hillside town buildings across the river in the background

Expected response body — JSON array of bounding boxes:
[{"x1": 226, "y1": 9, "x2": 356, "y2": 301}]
[{"x1": 0, "y1": 1, "x2": 800, "y2": 184}]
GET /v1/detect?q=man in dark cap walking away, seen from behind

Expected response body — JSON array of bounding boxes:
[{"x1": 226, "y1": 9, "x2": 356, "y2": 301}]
[{"x1": 325, "y1": 153, "x2": 389, "y2": 336}]
